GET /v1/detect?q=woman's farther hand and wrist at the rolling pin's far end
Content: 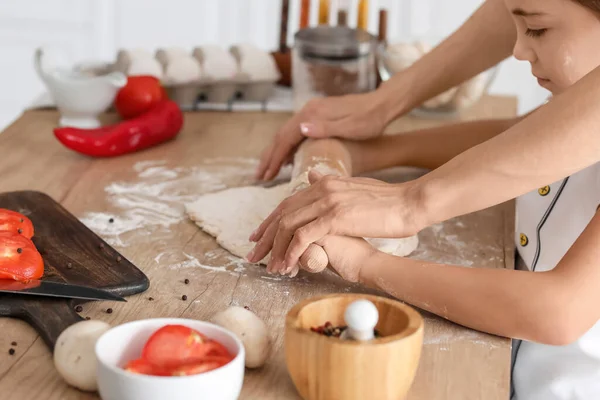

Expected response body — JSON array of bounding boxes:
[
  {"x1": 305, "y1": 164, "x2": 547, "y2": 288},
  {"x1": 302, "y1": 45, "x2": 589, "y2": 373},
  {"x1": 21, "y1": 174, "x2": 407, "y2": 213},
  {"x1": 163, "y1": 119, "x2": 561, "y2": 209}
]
[{"x1": 256, "y1": 91, "x2": 388, "y2": 180}]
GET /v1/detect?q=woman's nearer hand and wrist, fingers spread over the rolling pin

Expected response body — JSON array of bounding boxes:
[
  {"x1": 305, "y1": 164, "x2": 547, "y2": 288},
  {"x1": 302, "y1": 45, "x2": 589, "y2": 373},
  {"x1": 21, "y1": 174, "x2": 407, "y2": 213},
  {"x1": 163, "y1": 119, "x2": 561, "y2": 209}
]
[{"x1": 247, "y1": 170, "x2": 425, "y2": 274}]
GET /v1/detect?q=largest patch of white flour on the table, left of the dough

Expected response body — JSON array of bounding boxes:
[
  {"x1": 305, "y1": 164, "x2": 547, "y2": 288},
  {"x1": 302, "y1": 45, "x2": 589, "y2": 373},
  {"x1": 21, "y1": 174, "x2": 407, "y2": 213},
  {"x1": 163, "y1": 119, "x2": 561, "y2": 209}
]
[{"x1": 81, "y1": 157, "x2": 289, "y2": 247}]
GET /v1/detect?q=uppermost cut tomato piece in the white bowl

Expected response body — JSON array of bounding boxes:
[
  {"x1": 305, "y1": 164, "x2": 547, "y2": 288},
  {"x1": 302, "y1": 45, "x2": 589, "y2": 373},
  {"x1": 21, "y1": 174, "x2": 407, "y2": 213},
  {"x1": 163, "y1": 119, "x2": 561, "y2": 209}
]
[{"x1": 142, "y1": 325, "x2": 212, "y2": 367}]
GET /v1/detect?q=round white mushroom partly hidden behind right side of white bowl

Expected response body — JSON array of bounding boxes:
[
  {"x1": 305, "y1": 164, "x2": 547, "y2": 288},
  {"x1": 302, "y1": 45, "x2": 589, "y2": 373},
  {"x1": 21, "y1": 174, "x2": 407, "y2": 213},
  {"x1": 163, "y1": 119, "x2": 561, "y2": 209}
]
[{"x1": 212, "y1": 306, "x2": 271, "y2": 368}]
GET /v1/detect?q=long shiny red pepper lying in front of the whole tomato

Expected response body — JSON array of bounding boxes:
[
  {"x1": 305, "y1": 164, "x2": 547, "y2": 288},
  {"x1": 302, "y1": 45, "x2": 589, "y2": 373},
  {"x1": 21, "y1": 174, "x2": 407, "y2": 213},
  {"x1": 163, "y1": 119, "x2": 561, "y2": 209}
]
[{"x1": 54, "y1": 100, "x2": 183, "y2": 157}]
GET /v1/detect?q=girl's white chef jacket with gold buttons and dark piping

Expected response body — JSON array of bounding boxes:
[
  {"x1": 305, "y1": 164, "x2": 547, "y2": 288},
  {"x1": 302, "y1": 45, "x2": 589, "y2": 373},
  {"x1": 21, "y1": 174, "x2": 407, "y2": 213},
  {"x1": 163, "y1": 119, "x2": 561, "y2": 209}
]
[{"x1": 512, "y1": 163, "x2": 600, "y2": 400}]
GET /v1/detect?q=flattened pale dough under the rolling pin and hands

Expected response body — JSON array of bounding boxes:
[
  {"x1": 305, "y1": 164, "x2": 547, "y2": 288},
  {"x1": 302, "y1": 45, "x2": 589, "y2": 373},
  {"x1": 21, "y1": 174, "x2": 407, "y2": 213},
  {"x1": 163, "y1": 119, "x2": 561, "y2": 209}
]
[{"x1": 185, "y1": 173, "x2": 419, "y2": 265}]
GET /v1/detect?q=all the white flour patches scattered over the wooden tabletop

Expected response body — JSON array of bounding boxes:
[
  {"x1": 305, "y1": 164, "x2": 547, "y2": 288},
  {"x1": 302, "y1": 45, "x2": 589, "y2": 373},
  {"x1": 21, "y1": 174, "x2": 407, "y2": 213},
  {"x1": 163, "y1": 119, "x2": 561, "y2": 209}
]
[{"x1": 80, "y1": 157, "x2": 503, "y2": 351}]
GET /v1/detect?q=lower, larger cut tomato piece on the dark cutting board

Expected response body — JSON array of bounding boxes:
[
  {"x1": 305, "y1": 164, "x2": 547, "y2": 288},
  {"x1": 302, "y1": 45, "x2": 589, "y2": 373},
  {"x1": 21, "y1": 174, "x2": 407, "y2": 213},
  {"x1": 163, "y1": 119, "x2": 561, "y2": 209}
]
[{"x1": 0, "y1": 232, "x2": 44, "y2": 282}]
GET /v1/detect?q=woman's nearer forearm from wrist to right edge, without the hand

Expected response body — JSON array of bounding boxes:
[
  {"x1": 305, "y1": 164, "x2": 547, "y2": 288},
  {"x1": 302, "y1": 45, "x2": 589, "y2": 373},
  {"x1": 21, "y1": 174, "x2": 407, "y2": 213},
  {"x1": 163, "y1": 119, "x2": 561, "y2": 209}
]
[{"x1": 414, "y1": 67, "x2": 600, "y2": 228}]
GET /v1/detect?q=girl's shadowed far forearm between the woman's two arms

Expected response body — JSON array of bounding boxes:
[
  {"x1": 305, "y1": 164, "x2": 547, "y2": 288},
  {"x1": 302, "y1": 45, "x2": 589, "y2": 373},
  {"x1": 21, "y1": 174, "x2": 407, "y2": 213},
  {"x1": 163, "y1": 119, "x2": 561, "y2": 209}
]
[{"x1": 344, "y1": 117, "x2": 522, "y2": 175}]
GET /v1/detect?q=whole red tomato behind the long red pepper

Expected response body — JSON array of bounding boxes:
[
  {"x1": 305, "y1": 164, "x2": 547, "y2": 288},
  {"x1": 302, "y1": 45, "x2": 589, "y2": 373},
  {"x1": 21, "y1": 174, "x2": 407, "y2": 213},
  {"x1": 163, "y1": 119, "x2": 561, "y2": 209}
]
[{"x1": 115, "y1": 75, "x2": 167, "y2": 119}]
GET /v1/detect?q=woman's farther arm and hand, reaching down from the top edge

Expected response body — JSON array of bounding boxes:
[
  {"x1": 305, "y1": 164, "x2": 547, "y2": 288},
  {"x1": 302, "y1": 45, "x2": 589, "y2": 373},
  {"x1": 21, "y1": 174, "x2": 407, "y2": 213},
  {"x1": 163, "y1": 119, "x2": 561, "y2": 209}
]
[{"x1": 256, "y1": 0, "x2": 516, "y2": 180}]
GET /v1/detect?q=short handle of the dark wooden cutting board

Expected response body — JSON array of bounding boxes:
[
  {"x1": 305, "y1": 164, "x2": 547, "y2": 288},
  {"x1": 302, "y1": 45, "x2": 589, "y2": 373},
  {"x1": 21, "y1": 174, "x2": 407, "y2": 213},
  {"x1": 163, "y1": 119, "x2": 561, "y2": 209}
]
[{"x1": 20, "y1": 298, "x2": 83, "y2": 351}]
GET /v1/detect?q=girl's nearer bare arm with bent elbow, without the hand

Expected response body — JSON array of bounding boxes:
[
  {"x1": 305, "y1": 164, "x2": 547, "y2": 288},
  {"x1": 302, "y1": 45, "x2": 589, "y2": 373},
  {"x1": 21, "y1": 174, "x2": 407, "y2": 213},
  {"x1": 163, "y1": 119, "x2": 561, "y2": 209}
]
[{"x1": 359, "y1": 213, "x2": 600, "y2": 345}]
